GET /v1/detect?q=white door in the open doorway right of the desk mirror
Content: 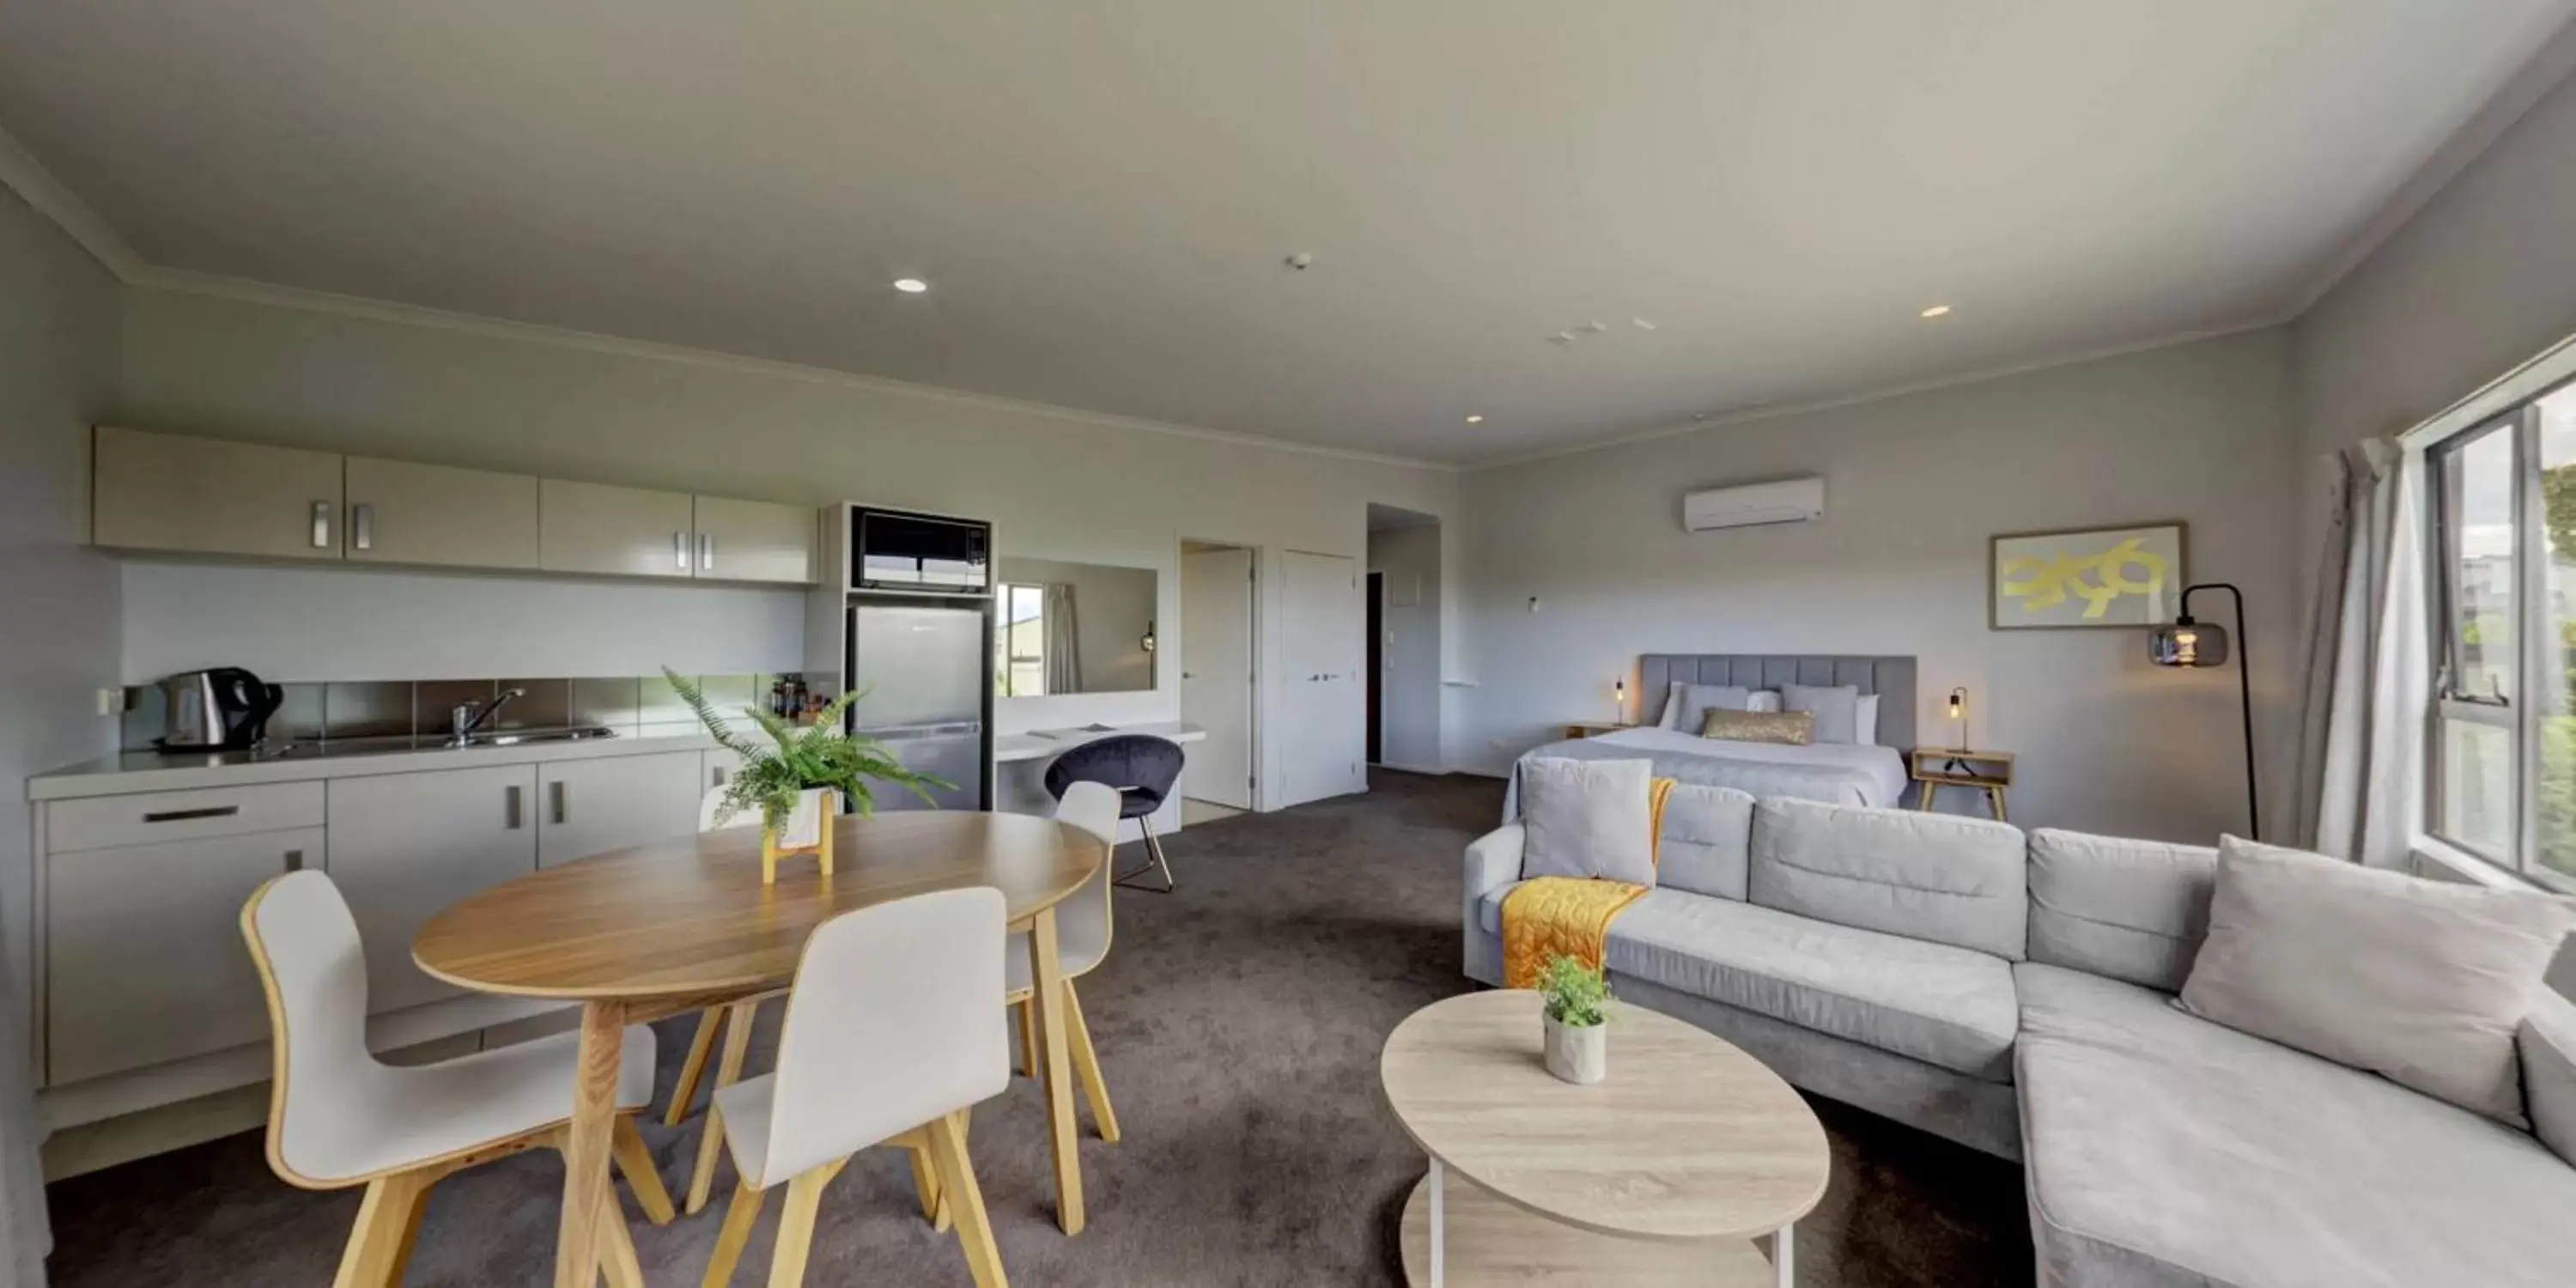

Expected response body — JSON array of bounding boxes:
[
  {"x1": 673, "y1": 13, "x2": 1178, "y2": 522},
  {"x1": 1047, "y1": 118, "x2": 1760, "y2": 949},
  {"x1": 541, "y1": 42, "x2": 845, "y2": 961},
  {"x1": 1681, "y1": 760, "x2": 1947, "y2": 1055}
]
[{"x1": 1180, "y1": 551, "x2": 1252, "y2": 809}]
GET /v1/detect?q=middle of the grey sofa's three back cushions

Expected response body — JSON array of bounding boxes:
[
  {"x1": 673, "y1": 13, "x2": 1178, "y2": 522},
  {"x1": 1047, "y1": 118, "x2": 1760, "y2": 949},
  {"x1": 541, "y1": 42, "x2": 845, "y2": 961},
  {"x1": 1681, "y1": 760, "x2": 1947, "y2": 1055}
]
[{"x1": 1747, "y1": 799, "x2": 2030, "y2": 961}]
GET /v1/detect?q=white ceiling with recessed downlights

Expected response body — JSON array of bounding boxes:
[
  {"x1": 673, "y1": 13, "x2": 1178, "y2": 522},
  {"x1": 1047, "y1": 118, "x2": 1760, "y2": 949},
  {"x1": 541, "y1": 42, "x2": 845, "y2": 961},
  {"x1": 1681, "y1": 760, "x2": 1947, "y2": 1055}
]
[{"x1": 0, "y1": 0, "x2": 2576, "y2": 464}]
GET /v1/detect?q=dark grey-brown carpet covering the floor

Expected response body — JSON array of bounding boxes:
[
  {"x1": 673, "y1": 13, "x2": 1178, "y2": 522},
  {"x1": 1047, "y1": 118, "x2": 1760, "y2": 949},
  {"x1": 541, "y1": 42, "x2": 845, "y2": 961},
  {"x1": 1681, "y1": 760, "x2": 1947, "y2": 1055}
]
[{"x1": 30, "y1": 773, "x2": 2032, "y2": 1288}]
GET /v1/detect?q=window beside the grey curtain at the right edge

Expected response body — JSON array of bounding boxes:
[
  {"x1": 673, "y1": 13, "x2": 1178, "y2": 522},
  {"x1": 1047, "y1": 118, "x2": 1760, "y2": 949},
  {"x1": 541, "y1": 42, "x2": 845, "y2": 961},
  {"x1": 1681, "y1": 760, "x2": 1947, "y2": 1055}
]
[{"x1": 2427, "y1": 384, "x2": 2576, "y2": 891}]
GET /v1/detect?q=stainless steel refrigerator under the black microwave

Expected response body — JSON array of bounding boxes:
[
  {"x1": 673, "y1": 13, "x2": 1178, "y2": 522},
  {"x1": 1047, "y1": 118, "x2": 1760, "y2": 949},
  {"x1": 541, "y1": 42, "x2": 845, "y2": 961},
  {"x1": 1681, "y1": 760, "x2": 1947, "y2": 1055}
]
[{"x1": 842, "y1": 592, "x2": 992, "y2": 809}]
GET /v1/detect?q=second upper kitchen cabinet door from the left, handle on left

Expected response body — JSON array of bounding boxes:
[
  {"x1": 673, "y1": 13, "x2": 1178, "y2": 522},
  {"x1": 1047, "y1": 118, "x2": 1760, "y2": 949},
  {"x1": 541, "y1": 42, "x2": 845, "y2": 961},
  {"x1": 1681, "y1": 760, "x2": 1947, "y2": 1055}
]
[{"x1": 343, "y1": 456, "x2": 538, "y2": 569}]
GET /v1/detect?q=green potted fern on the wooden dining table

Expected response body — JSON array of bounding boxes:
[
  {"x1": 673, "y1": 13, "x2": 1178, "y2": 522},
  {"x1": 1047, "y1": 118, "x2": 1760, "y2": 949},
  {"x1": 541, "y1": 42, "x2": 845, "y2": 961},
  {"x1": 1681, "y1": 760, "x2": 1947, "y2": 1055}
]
[{"x1": 662, "y1": 667, "x2": 951, "y2": 884}]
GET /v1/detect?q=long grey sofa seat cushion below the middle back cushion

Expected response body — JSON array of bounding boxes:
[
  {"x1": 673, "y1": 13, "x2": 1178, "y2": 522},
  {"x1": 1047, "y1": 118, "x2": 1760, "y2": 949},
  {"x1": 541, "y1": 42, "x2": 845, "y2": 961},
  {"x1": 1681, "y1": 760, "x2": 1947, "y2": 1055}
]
[{"x1": 1602, "y1": 889, "x2": 2014, "y2": 1082}]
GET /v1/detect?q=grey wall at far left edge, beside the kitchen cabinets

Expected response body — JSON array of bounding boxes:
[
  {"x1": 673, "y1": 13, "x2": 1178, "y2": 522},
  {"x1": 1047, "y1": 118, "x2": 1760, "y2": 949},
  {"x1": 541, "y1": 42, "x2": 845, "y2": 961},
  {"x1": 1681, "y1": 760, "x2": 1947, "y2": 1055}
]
[{"x1": 0, "y1": 176, "x2": 116, "y2": 1262}]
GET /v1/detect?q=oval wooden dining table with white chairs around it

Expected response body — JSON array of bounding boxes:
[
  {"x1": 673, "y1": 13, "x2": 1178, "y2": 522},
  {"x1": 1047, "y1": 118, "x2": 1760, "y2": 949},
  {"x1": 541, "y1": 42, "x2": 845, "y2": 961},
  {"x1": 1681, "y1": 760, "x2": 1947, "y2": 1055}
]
[{"x1": 412, "y1": 811, "x2": 1108, "y2": 1288}]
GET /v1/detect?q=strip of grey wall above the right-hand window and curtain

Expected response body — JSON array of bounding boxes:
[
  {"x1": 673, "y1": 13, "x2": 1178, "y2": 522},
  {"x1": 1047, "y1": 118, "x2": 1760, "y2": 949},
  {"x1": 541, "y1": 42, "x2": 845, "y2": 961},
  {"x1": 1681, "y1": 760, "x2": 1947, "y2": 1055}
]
[{"x1": 2290, "y1": 61, "x2": 2576, "y2": 456}]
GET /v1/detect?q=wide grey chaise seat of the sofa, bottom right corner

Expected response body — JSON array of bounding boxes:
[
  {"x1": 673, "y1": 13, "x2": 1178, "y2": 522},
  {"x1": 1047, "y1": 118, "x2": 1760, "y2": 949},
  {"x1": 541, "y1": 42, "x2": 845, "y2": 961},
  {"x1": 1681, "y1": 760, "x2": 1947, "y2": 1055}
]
[{"x1": 2014, "y1": 963, "x2": 2576, "y2": 1288}]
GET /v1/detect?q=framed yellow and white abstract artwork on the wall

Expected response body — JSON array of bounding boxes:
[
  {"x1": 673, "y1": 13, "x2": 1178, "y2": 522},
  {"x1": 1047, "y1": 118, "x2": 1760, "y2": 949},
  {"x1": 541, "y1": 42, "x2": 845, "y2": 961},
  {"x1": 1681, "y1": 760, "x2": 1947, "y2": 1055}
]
[{"x1": 1986, "y1": 520, "x2": 2190, "y2": 631}]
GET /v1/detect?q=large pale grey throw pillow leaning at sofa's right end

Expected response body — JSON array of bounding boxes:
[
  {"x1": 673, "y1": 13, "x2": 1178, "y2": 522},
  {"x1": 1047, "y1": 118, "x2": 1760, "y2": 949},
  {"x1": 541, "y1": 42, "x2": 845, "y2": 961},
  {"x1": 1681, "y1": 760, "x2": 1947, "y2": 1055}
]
[{"x1": 2182, "y1": 837, "x2": 2576, "y2": 1128}]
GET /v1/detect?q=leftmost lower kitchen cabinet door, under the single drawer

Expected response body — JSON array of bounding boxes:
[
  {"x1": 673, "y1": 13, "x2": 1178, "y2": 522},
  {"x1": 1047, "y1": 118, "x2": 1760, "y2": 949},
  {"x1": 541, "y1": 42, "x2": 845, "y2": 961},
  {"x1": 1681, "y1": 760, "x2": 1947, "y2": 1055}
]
[{"x1": 44, "y1": 827, "x2": 325, "y2": 1087}]
